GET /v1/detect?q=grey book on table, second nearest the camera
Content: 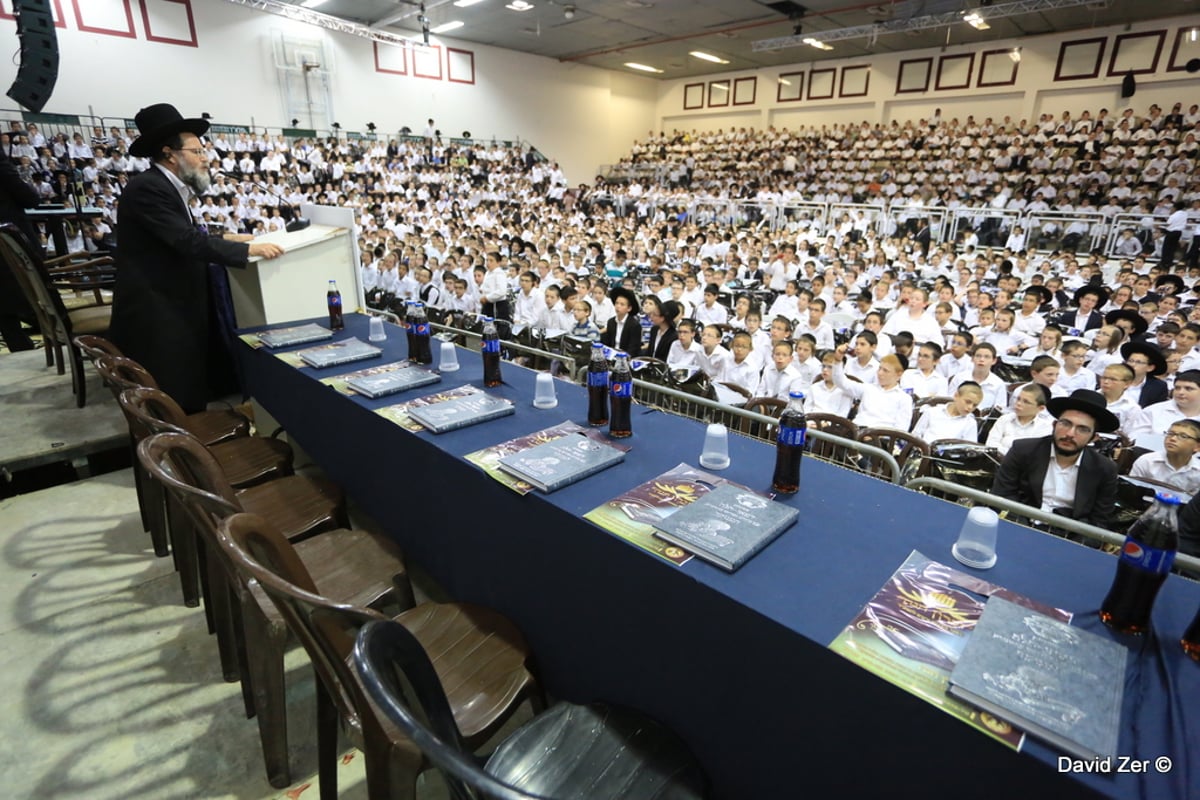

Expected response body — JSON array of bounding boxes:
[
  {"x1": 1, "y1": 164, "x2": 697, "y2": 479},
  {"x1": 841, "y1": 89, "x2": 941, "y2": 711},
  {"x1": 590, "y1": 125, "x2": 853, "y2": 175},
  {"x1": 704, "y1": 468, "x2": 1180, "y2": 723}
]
[{"x1": 654, "y1": 483, "x2": 800, "y2": 572}]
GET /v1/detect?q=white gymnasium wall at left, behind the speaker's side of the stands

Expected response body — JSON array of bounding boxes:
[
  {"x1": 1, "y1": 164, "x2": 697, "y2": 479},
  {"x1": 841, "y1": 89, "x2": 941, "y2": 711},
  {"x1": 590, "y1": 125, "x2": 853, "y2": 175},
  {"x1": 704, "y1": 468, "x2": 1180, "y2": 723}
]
[{"x1": 0, "y1": 0, "x2": 658, "y2": 182}]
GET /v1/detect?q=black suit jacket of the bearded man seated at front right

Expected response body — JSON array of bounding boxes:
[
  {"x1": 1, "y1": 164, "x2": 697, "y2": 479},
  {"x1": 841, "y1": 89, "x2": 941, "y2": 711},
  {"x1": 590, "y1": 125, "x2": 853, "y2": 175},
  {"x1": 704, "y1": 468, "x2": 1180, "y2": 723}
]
[{"x1": 991, "y1": 437, "x2": 1117, "y2": 528}]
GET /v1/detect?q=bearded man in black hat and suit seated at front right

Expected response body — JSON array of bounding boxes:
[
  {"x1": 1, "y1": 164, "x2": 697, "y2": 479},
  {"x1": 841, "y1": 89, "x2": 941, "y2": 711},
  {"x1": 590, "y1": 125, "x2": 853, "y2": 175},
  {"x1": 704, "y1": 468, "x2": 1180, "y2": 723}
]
[{"x1": 991, "y1": 389, "x2": 1118, "y2": 528}]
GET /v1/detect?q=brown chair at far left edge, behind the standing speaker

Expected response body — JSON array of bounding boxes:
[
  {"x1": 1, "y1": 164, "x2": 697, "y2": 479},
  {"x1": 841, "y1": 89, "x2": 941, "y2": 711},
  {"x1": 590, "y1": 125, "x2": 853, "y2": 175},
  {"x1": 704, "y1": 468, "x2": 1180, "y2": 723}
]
[{"x1": 0, "y1": 224, "x2": 113, "y2": 408}]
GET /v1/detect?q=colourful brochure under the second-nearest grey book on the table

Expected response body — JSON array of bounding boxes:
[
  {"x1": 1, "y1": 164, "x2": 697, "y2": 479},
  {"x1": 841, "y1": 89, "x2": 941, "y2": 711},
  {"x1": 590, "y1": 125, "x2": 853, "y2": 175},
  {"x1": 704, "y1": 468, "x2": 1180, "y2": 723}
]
[{"x1": 583, "y1": 464, "x2": 766, "y2": 565}]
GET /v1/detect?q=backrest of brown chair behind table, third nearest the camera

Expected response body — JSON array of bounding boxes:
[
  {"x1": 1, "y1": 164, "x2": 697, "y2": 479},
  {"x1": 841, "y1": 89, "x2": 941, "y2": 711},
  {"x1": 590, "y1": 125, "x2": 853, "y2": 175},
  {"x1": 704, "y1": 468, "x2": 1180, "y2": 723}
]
[{"x1": 138, "y1": 433, "x2": 241, "y2": 531}]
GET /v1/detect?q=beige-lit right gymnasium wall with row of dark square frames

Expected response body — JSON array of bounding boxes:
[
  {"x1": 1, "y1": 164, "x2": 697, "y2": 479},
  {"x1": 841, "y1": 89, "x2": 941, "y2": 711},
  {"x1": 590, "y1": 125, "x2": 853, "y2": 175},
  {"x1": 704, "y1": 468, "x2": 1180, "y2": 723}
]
[{"x1": 656, "y1": 14, "x2": 1200, "y2": 132}]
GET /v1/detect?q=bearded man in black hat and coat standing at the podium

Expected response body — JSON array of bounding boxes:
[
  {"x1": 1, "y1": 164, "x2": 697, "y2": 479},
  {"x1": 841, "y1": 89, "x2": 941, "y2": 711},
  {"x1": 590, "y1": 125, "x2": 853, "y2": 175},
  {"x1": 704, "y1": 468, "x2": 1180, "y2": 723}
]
[{"x1": 109, "y1": 103, "x2": 283, "y2": 413}]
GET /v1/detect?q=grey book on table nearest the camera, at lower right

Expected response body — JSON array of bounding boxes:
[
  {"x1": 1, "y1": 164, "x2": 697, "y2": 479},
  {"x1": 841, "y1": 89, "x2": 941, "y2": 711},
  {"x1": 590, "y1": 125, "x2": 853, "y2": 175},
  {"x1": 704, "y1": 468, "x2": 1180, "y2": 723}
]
[{"x1": 947, "y1": 597, "x2": 1129, "y2": 760}]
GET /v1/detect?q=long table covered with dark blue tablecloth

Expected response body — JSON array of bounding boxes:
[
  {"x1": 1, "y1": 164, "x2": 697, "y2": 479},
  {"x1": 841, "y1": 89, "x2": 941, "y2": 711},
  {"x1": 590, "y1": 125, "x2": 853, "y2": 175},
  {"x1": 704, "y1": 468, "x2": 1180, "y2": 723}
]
[{"x1": 240, "y1": 317, "x2": 1200, "y2": 800}]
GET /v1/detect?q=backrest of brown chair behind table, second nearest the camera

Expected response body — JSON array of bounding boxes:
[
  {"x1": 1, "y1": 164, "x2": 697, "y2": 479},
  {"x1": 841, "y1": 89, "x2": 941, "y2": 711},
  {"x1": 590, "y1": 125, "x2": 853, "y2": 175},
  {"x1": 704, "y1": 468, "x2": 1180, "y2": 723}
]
[{"x1": 216, "y1": 513, "x2": 386, "y2": 741}]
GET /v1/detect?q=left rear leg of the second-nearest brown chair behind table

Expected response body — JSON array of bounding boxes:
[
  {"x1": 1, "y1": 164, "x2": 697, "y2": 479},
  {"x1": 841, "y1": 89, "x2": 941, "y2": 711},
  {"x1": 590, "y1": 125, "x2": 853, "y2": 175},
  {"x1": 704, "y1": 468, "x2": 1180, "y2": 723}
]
[{"x1": 240, "y1": 596, "x2": 291, "y2": 798}]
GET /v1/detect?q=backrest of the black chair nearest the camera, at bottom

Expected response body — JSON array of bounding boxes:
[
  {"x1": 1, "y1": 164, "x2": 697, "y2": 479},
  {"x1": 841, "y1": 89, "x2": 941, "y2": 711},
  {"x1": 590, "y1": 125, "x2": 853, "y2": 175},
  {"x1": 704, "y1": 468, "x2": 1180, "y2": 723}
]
[{"x1": 354, "y1": 620, "x2": 544, "y2": 800}]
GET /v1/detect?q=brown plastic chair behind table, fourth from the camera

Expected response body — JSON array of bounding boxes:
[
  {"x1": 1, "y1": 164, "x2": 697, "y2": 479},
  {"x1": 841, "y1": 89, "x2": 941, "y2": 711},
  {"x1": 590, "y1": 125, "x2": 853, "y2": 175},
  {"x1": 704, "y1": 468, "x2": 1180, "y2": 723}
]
[{"x1": 118, "y1": 386, "x2": 293, "y2": 606}]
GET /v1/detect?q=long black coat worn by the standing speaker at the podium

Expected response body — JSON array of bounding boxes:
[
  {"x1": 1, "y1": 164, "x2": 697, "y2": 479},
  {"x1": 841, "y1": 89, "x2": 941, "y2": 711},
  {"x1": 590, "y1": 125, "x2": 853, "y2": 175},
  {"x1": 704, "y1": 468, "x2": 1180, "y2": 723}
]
[{"x1": 109, "y1": 167, "x2": 250, "y2": 413}]
